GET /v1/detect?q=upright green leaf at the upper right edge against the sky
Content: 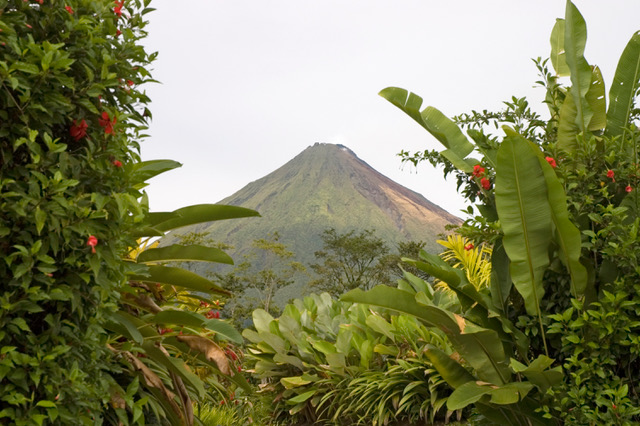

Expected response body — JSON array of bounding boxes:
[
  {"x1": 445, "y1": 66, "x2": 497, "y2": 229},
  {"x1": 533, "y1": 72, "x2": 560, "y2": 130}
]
[{"x1": 607, "y1": 31, "x2": 640, "y2": 136}]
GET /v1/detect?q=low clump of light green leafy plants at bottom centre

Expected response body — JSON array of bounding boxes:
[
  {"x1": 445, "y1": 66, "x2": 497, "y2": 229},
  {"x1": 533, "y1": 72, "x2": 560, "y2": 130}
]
[{"x1": 243, "y1": 293, "x2": 458, "y2": 425}]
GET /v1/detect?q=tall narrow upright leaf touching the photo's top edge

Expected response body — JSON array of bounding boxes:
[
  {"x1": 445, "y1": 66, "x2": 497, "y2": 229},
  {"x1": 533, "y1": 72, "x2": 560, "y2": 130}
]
[{"x1": 564, "y1": 0, "x2": 593, "y2": 132}]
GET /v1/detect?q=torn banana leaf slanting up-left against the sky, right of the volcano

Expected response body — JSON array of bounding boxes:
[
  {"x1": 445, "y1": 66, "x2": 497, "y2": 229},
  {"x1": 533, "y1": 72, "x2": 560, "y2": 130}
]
[{"x1": 379, "y1": 87, "x2": 477, "y2": 173}]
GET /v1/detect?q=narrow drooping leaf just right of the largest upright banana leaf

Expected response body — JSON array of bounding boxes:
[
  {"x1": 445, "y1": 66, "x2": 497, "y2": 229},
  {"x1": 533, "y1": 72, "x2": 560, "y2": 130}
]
[{"x1": 538, "y1": 154, "x2": 587, "y2": 298}]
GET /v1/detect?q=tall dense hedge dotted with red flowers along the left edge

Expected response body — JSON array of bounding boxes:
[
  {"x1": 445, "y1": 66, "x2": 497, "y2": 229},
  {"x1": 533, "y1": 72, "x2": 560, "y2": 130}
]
[{"x1": 0, "y1": 0, "x2": 153, "y2": 424}]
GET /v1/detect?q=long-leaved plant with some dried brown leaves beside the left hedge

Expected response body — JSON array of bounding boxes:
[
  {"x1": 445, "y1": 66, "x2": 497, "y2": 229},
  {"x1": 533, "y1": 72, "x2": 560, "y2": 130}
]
[{"x1": 107, "y1": 160, "x2": 258, "y2": 425}]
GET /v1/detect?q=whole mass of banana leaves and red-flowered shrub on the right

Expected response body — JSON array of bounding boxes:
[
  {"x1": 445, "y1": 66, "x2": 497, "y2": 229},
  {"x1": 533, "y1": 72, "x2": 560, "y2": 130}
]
[{"x1": 343, "y1": 1, "x2": 640, "y2": 424}]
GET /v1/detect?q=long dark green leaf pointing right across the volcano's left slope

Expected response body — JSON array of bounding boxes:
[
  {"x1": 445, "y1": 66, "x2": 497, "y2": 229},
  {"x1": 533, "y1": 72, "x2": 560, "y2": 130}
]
[{"x1": 154, "y1": 204, "x2": 260, "y2": 232}]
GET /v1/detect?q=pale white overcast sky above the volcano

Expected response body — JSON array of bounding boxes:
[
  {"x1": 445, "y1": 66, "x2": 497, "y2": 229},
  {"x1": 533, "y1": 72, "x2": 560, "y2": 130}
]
[{"x1": 142, "y1": 0, "x2": 640, "y2": 215}]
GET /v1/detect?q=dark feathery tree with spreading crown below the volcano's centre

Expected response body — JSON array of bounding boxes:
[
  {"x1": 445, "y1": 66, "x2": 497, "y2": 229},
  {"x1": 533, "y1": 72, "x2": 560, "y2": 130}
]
[{"x1": 310, "y1": 228, "x2": 395, "y2": 295}]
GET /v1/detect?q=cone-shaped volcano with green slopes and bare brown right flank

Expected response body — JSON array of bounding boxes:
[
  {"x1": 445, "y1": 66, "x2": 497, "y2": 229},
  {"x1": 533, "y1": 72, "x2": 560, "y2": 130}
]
[{"x1": 170, "y1": 143, "x2": 460, "y2": 264}]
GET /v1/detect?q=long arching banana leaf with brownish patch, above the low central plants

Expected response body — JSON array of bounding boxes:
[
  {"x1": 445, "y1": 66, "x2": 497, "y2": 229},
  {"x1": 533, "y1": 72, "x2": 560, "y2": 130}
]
[{"x1": 341, "y1": 285, "x2": 510, "y2": 384}]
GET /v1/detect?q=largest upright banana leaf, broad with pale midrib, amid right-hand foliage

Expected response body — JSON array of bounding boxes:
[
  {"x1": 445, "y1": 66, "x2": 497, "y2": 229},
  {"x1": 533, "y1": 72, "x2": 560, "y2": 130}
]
[{"x1": 495, "y1": 135, "x2": 551, "y2": 318}]
